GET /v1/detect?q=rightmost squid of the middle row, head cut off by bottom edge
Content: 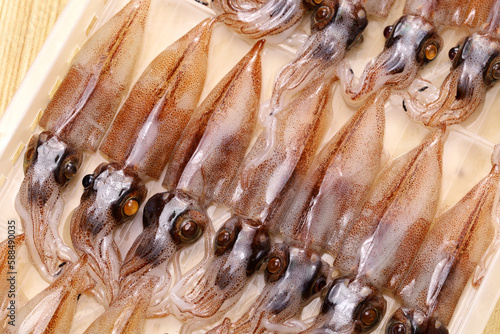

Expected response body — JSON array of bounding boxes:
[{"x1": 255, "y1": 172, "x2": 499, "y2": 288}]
[{"x1": 387, "y1": 146, "x2": 500, "y2": 333}]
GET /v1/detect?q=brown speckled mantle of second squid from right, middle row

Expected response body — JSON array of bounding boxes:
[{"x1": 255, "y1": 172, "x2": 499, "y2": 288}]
[{"x1": 334, "y1": 129, "x2": 446, "y2": 289}]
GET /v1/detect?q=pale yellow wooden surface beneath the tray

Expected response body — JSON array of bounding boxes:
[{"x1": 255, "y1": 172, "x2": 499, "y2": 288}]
[{"x1": 0, "y1": 0, "x2": 500, "y2": 334}]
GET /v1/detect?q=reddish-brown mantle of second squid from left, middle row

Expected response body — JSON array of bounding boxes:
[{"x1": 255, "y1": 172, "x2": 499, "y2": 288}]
[{"x1": 100, "y1": 19, "x2": 215, "y2": 179}]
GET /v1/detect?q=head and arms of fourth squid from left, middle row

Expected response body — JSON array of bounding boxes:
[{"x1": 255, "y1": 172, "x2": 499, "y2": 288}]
[{"x1": 170, "y1": 217, "x2": 271, "y2": 333}]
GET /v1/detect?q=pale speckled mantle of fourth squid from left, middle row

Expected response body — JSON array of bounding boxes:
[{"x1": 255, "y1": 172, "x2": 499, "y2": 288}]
[{"x1": 224, "y1": 78, "x2": 334, "y2": 219}]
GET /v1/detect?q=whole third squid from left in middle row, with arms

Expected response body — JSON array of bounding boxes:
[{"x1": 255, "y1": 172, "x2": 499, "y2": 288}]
[{"x1": 89, "y1": 35, "x2": 264, "y2": 333}]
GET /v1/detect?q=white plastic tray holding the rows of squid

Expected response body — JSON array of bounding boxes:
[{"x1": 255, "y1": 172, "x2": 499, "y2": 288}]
[{"x1": 0, "y1": 0, "x2": 500, "y2": 334}]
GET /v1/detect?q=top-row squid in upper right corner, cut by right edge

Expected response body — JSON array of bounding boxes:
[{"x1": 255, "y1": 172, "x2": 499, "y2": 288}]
[{"x1": 404, "y1": 1, "x2": 500, "y2": 126}]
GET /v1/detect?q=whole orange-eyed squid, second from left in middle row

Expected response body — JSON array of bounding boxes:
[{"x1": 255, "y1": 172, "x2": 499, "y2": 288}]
[{"x1": 71, "y1": 19, "x2": 214, "y2": 299}]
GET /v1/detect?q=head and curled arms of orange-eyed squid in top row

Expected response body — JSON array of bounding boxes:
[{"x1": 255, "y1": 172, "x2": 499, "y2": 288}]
[{"x1": 338, "y1": 15, "x2": 443, "y2": 103}]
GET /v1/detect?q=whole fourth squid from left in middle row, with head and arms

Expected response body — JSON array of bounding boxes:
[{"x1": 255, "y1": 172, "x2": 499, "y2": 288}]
[{"x1": 171, "y1": 72, "x2": 335, "y2": 333}]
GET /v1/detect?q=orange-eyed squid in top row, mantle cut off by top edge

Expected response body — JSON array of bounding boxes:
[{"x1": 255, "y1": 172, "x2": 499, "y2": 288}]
[{"x1": 338, "y1": 1, "x2": 468, "y2": 104}]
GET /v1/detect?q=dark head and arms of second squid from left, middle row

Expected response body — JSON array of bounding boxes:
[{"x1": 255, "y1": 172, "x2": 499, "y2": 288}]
[{"x1": 70, "y1": 163, "x2": 147, "y2": 301}]
